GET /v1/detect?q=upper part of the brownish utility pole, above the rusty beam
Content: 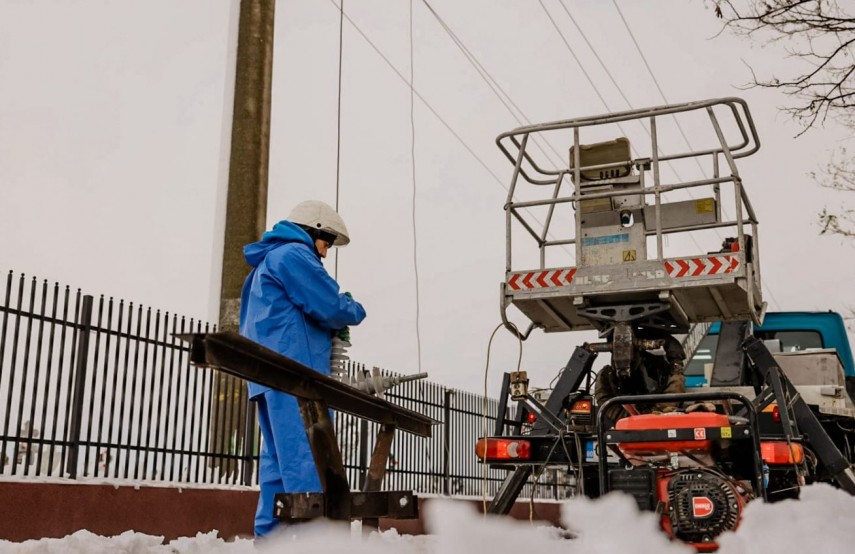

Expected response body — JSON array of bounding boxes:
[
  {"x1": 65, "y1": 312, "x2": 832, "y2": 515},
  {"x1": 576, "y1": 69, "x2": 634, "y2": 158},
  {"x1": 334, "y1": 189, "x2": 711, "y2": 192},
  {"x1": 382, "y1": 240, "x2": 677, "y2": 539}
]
[{"x1": 219, "y1": 0, "x2": 276, "y2": 331}]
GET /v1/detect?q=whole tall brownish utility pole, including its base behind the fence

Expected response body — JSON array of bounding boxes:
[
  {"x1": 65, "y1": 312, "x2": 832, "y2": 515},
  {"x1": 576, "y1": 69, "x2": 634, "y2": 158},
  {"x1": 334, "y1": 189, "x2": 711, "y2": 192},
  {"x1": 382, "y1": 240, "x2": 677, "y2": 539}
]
[{"x1": 209, "y1": 0, "x2": 276, "y2": 474}]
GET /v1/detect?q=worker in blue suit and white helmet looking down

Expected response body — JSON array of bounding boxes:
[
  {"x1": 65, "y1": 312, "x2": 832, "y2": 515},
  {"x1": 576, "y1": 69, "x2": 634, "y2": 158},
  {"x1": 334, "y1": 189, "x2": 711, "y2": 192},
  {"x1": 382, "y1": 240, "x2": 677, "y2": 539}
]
[{"x1": 240, "y1": 200, "x2": 365, "y2": 537}]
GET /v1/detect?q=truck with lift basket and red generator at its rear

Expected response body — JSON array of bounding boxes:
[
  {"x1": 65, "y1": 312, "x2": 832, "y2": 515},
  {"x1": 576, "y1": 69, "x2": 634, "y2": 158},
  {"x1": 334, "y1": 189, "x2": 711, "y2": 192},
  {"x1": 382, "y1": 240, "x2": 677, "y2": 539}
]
[{"x1": 476, "y1": 98, "x2": 855, "y2": 551}]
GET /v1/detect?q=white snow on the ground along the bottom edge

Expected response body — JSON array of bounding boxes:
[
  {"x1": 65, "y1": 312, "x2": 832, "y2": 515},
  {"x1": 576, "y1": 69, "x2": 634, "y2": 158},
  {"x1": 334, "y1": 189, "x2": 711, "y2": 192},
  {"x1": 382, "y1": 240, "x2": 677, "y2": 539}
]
[{"x1": 0, "y1": 485, "x2": 855, "y2": 554}]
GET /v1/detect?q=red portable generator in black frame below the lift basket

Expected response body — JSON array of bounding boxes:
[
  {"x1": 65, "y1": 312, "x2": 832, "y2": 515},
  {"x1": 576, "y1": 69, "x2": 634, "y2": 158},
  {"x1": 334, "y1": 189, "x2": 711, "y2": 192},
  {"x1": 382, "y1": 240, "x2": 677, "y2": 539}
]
[{"x1": 598, "y1": 392, "x2": 766, "y2": 552}]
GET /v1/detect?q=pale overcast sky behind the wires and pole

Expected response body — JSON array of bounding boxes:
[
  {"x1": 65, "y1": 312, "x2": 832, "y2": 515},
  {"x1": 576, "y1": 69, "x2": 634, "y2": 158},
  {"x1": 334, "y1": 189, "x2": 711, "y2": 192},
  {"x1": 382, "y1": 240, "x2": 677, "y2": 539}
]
[{"x1": 0, "y1": 0, "x2": 855, "y2": 394}]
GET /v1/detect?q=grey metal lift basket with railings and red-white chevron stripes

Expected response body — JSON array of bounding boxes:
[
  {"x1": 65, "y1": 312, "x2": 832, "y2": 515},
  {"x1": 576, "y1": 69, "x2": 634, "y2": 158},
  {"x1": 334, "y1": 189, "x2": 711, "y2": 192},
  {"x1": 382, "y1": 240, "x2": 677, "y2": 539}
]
[{"x1": 496, "y1": 98, "x2": 765, "y2": 335}]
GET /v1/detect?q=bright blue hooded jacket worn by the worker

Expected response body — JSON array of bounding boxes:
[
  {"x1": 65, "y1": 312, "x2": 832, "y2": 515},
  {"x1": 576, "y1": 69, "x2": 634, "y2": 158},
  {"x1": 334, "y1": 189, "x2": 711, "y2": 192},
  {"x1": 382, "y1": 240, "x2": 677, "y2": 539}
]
[{"x1": 240, "y1": 217, "x2": 365, "y2": 398}]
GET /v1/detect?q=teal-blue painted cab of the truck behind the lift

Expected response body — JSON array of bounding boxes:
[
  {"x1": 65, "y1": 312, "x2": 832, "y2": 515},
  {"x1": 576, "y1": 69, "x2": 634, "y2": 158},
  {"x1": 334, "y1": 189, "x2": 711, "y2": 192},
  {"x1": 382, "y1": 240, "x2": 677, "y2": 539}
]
[{"x1": 685, "y1": 311, "x2": 855, "y2": 388}]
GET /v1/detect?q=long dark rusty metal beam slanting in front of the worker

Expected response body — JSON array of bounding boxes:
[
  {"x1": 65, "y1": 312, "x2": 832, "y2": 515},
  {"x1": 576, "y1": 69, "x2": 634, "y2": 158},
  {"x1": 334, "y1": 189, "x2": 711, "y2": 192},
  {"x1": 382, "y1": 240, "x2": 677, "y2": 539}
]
[{"x1": 177, "y1": 332, "x2": 436, "y2": 437}]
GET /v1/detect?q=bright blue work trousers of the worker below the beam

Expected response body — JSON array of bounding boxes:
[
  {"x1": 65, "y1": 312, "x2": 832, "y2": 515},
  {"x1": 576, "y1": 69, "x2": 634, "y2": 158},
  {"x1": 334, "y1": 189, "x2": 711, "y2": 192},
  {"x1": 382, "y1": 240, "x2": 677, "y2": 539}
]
[{"x1": 255, "y1": 390, "x2": 322, "y2": 537}]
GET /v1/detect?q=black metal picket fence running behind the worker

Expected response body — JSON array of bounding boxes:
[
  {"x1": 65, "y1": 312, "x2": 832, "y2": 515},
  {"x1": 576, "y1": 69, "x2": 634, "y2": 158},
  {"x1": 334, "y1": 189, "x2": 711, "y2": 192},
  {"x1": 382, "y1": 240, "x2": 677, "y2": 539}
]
[{"x1": 0, "y1": 271, "x2": 566, "y2": 498}]
